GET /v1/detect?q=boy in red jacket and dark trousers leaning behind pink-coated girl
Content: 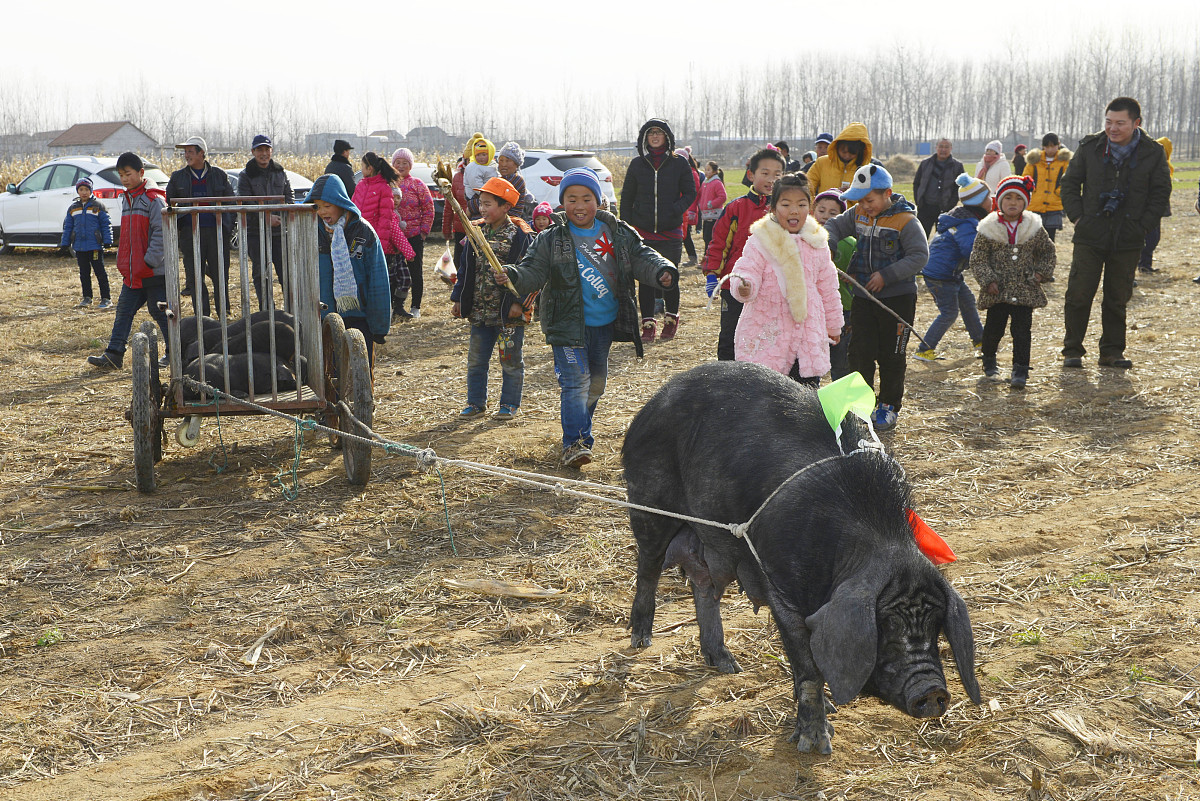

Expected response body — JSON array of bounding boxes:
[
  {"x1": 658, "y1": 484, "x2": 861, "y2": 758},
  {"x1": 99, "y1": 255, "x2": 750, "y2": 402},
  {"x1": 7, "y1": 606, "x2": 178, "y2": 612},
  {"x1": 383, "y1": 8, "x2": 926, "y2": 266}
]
[{"x1": 702, "y1": 147, "x2": 786, "y2": 362}]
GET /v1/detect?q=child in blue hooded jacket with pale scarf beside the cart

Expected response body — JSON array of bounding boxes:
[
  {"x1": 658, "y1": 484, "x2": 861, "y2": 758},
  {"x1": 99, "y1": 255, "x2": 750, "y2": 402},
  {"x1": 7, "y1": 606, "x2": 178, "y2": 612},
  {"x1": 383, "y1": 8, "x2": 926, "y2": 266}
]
[{"x1": 305, "y1": 174, "x2": 391, "y2": 368}]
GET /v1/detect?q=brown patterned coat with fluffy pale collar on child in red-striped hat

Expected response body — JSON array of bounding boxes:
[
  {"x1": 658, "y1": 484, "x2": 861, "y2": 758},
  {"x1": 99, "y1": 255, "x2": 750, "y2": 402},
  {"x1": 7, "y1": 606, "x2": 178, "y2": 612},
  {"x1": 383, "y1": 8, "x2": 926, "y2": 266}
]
[{"x1": 971, "y1": 211, "x2": 1055, "y2": 309}]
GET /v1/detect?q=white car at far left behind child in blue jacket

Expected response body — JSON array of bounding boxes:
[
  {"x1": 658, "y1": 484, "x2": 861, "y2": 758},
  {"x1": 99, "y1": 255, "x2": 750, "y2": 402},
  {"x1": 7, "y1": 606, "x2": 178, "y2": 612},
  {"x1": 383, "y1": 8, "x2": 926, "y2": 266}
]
[{"x1": 0, "y1": 156, "x2": 169, "y2": 253}]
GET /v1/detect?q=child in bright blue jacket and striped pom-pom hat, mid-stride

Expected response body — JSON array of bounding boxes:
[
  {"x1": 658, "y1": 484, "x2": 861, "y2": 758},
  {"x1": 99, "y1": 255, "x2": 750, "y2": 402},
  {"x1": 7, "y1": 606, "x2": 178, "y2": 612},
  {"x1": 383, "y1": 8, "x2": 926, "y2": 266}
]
[{"x1": 914, "y1": 173, "x2": 991, "y2": 362}]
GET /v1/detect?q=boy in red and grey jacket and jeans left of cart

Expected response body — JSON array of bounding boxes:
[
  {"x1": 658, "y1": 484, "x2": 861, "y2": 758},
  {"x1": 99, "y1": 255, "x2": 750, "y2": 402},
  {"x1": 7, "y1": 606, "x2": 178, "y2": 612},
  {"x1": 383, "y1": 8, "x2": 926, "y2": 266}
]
[{"x1": 88, "y1": 152, "x2": 167, "y2": 369}]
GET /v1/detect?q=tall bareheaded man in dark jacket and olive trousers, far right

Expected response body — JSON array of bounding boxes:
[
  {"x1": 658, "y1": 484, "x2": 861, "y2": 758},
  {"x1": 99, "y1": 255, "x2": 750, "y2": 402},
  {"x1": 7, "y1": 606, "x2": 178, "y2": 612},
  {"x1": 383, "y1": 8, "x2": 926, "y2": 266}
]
[{"x1": 1062, "y1": 97, "x2": 1171, "y2": 369}]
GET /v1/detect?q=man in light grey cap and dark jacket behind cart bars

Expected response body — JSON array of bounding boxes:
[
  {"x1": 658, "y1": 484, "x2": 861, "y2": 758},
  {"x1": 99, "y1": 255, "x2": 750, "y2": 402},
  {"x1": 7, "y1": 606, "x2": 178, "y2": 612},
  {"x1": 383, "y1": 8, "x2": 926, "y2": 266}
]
[{"x1": 167, "y1": 137, "x2": 234, "y2": 314}]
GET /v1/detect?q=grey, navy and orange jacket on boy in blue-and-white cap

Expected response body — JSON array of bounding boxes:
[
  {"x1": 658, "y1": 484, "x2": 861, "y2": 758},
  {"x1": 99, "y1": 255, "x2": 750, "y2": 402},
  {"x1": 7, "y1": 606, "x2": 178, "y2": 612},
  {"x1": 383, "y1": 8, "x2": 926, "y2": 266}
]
[{"x1": 826, "y1": 193, "x2": 929, "y2": 297}]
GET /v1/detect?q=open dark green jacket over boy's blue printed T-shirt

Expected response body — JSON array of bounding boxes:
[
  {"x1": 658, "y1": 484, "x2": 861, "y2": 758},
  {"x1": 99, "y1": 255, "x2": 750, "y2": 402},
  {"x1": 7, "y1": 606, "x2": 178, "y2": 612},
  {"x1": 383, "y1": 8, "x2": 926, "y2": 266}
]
[{"x1": 506, "y1": 209, "x2": 679, "y2": 356}]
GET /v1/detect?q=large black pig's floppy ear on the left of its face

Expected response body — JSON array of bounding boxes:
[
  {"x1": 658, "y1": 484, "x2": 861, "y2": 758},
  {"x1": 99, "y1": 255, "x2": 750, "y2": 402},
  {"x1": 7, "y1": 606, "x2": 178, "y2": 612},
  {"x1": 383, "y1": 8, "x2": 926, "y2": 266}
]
[{"x1": 804, "y1": 576, "x2": 880, "y2": 704}]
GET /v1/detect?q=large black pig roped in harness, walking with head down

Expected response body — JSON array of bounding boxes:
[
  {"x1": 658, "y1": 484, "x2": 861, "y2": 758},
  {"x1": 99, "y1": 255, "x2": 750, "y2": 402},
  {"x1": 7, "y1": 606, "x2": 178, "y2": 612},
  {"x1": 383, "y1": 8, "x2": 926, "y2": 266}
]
[{"x1": 622, "y1": 362, "x2": 980, "y2": 754}]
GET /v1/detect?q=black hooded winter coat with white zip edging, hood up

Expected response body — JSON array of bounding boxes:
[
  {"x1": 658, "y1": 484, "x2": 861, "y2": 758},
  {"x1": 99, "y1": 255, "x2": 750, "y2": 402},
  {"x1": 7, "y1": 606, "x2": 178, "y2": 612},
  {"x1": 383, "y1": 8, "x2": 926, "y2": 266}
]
[{"x1": 620, "y1": 120, "x2": 696, "y2": 234}]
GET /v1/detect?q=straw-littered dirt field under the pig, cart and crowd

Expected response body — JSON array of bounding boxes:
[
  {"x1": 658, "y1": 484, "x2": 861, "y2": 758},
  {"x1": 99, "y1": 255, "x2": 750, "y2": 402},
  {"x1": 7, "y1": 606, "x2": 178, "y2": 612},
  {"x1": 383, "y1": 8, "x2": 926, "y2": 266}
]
[{"x1": 0, "y1": 195, "x2": 1200, "y2": 801}]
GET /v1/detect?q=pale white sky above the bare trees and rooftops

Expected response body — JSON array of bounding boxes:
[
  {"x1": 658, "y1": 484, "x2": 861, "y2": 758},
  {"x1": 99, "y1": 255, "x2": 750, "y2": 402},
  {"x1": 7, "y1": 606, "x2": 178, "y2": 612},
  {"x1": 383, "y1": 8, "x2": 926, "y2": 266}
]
[{"x1": 9, "y1": 0, "x2": 1200, "y2": 133}]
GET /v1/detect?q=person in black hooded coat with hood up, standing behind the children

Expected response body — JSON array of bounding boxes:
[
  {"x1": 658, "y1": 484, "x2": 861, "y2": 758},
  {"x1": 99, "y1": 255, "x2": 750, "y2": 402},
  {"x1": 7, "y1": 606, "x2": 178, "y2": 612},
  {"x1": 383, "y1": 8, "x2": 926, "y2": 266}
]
[{"x1": 620, "y1": 119, "x2": 696, "y2": 342}]
